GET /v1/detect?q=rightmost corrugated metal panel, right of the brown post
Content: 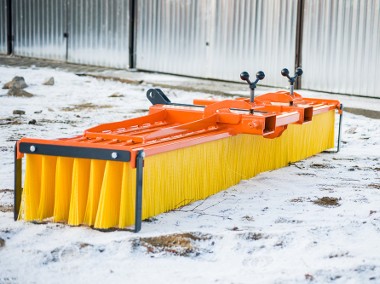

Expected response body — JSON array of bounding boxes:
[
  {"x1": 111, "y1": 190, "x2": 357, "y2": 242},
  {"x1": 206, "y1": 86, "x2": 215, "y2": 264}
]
[{"x1": 302, "y1": 0, "x2": 380, "y2": 97}]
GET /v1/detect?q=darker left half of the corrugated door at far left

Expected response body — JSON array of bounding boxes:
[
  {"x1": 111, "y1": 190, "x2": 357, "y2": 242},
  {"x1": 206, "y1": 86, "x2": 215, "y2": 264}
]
[{"x1": 12, "y1": 0, "x2": 66, "y2": 60}]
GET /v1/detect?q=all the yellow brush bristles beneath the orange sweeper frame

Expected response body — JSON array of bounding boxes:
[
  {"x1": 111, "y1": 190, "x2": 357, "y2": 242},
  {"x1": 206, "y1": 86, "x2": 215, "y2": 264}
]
[{"x1": 20, "y1": 110, "x2": 335, "y2": 229}]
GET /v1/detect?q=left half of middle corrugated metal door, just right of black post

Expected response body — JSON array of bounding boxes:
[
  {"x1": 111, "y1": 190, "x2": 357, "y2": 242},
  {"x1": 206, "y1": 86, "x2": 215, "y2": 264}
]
[{"x1": 136, "y1": 0, "x2": 210, "y2": 77}]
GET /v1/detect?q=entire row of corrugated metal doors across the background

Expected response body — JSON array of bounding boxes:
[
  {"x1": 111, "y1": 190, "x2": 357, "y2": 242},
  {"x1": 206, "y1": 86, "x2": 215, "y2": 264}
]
[{"x1": 0, "y1": 0, "x2": 380, "y2": 97}]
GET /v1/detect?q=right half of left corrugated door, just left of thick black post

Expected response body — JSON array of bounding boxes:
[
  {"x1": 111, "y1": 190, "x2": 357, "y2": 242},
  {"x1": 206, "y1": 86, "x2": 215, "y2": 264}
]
[{"x1": 68, "y1": 0, "x2": 129, "y2": 68}]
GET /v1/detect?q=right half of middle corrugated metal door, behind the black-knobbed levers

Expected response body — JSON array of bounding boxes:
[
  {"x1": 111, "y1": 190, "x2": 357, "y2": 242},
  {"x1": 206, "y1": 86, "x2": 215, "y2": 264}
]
[{"x1": 208, "y1": 0, "x2": 297, "y2": 86}]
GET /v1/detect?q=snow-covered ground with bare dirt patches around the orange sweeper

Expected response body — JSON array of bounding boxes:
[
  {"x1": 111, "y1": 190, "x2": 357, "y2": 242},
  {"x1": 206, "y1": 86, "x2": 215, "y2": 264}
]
[{"x1": 0, "y1": 66, "x2": 380, "y2": 283}]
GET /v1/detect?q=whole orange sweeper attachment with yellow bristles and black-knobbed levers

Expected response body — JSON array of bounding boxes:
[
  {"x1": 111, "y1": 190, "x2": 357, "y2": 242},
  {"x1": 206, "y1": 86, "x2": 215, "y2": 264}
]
[{"x1": 14, "y1": 68, "x2": 342, "y2": 232}]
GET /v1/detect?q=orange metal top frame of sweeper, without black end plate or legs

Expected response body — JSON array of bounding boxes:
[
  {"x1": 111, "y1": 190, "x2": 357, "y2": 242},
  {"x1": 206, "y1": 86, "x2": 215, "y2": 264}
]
[{"x1": 17, "y1": 91, "x2": 339, "y2": 167}]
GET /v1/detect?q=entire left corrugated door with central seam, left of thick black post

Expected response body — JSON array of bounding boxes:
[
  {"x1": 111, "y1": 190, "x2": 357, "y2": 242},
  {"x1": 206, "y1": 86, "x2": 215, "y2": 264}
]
[{"x1": 9, "y1": 0, "x2": 129, "y2": 68}]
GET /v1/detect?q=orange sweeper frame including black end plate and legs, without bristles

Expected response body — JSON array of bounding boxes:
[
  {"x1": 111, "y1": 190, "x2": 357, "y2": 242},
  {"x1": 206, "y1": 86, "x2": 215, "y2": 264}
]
[{"x1": 14, "y1": 90, "x2": 341, "y2": 232}]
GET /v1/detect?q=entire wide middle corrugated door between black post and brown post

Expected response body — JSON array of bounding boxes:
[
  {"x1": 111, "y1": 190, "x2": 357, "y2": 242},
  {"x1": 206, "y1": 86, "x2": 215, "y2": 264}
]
[{"x1": 136, "y1": 0, "x2": 298, "y2": 86}]
